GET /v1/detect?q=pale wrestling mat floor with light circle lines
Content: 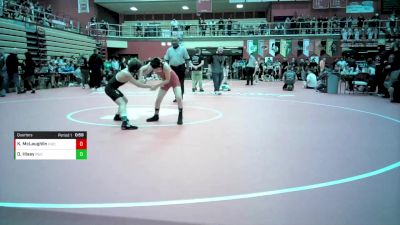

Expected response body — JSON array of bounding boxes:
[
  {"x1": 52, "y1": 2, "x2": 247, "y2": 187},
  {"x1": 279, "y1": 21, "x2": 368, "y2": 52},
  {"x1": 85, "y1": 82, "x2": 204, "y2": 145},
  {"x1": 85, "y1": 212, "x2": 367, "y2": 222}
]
[{"x1": 0, "y1": 81, "x2": 400, "y2": 225}]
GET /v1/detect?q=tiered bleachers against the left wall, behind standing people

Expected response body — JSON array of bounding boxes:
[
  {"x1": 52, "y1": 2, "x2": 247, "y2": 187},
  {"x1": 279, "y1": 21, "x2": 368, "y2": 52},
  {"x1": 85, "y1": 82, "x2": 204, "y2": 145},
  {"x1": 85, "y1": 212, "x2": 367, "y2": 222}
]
[{"x1": 0, "y1": 18, "x2": 97, "y2": 88}]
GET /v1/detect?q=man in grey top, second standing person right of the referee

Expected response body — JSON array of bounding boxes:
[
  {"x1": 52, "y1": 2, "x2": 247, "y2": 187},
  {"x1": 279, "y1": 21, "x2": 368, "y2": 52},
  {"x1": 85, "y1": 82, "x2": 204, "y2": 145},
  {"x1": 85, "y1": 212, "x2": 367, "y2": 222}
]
[{"x1": 208, "y1": 47, "x2": 226, "y2": 95}]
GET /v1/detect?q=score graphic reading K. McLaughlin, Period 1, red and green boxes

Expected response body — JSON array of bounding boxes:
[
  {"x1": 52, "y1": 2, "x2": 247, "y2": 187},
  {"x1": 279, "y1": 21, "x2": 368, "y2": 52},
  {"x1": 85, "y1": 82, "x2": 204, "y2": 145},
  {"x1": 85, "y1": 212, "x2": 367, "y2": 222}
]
[{"x1": 14, "y1": 131, "x2": 87, "y2": 160}]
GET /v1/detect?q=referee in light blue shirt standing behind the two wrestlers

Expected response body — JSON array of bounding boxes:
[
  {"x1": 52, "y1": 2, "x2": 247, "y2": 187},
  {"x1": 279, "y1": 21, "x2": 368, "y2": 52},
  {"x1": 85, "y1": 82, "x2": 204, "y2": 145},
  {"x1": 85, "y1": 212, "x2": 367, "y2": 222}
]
[{"x1": 164, "y1": 38, "x2": 189, "y2": 102}]
